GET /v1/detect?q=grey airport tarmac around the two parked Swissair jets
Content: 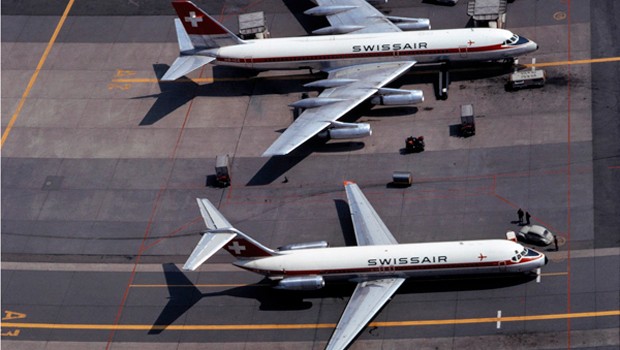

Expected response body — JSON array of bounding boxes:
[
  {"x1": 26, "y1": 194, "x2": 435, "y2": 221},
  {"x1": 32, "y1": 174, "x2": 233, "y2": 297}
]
[{"x1": 1, "y1": 0, "x2": 620, "y2": 349}]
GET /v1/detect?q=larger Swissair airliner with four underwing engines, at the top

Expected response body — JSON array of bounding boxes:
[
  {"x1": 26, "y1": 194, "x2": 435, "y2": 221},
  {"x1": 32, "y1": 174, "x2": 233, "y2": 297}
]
[{"x1": 161, "y1": 0, "x2": 538, "y2": 156}]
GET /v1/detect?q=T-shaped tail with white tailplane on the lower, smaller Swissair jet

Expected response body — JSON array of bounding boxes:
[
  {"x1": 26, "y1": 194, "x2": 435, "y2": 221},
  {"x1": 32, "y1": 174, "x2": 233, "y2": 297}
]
[{"x1": 183, "y1": 198, "x2": 277, "y2": 271}]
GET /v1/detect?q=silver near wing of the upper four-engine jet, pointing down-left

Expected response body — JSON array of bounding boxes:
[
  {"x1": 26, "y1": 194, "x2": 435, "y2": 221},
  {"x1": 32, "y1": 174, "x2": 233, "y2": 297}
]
[{"x1": 263, "y1": 61, "x2": 416, "y2": 157}]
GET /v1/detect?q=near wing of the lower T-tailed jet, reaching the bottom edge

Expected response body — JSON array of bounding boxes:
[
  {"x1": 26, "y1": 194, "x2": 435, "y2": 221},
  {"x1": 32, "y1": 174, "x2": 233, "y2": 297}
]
[{"x1": 325, "y1": 278, "x2": 405, "y2": 350}]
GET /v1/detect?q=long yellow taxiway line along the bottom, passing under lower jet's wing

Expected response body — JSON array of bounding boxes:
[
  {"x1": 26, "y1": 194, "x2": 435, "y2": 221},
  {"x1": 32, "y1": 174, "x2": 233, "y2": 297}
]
[{"x1": 0, "y1": 310, "x2": 620, "y2": 331}]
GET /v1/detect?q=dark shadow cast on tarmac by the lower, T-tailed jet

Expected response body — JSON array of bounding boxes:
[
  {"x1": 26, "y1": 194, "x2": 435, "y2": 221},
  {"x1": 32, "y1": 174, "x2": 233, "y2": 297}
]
[{"x1": 148, "y1": 263, "x2": 536, "y2": 335}]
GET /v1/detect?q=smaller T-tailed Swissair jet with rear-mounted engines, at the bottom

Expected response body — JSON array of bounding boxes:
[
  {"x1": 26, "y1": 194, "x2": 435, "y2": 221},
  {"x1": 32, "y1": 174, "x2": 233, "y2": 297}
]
[{"x1": 183, "y1": 182, "x2": 547, "y2": 349}]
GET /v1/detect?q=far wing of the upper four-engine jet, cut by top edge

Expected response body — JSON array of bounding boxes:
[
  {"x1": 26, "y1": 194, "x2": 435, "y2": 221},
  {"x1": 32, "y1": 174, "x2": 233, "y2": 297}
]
[{"x1": 315, "y1": 0, "x2": 401, "y2": 34}]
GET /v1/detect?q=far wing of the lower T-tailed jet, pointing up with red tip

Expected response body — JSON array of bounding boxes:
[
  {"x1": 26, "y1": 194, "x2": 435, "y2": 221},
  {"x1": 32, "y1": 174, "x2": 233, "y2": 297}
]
[{"x1": 344, "y1": 181, "x2": 398, "y2": 245}]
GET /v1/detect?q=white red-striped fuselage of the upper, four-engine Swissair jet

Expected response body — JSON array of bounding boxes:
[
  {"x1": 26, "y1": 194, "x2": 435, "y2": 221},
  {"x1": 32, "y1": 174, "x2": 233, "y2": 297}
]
[{"x1": 198, "y1": 28, "x2": 538, "y2": 70}]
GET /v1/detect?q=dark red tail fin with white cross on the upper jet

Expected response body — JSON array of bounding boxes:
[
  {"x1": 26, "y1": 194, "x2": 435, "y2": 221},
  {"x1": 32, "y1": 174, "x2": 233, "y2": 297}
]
[{"x1": 172, "y1": 0, "x2": 245, "y2": 49}]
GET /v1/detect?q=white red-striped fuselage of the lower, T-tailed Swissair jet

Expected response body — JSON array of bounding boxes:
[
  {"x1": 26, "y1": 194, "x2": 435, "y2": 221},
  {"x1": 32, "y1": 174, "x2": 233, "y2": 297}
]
[{"x1": 234, "y1": 239, "x2": 545, "y2": 279}]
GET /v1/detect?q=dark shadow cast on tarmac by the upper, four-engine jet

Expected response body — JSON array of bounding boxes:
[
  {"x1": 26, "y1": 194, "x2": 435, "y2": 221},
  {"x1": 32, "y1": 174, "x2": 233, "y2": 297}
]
[{"x1": 134, "y1": 62, "x2": 513, "y2": 186}]
